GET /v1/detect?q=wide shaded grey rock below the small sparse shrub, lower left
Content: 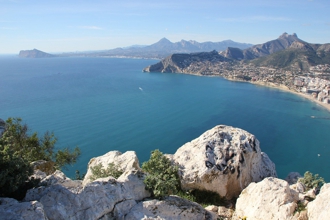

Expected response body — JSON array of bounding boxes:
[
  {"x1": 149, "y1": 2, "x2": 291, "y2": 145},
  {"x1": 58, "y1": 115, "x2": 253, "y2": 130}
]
[{"x1": 25, "y1": 170, "x2": 150, "y2": 220}]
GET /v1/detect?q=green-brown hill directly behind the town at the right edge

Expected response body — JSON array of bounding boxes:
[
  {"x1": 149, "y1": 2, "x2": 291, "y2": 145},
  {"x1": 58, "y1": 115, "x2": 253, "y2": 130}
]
[{"x1": 250, "y1": 41, "x2": 330, "y2": 71}]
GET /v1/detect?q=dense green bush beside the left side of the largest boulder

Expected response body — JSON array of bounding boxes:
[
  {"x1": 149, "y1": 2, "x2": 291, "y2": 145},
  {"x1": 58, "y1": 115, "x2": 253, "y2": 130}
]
[{"x1": 142, "y1": 150, "x2": 180, "y2": 198}]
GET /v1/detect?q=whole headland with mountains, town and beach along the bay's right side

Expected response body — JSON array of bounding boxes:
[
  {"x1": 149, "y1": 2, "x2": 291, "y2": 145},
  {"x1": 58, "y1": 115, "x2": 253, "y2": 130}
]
[{"x1": 143, "y1": 33, "x2": 330, "y2": 110}]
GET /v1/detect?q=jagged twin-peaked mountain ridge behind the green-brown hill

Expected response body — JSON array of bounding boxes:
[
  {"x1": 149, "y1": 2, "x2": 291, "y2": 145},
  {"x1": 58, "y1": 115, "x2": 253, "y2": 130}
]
[{"x1": 221, "y1": 33, "x2": 304, "y2": 60}]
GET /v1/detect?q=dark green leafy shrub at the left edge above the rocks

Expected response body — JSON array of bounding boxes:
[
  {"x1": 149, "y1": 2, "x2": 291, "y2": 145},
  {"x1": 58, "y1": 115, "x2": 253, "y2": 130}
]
[{"x1": 0, "y1": 118, "x2": 80, "y2": 199}]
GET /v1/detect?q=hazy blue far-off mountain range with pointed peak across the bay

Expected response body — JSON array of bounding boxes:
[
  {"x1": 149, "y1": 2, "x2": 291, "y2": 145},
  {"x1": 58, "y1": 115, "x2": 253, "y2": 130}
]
[{"x1": 72, "y1": 38, "x2": 252, "y2": 59}]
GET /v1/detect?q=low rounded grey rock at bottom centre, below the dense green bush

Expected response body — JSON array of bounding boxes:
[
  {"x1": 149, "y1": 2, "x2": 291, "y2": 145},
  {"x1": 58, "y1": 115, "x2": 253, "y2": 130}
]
[{"x1": 125, "y1": 196, "x2": 217, "y2": 220}]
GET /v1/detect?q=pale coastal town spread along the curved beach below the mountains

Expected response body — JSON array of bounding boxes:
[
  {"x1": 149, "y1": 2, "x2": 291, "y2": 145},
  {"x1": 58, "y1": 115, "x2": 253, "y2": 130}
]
[{"x1": 170, "y1": 61, "x2": 330, "y2": 108}]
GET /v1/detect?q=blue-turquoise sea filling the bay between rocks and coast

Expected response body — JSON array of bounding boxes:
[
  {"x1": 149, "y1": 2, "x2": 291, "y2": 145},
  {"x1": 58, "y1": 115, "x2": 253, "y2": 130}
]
[{"x1": 0, "y1": 57, "x2": 330, "y2": 181}]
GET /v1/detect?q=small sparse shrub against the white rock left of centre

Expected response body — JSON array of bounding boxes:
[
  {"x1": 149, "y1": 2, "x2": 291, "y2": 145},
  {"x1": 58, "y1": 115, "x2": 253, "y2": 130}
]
[{"x1": 89, "y1": 163, "x2": 123, "y2": 181}]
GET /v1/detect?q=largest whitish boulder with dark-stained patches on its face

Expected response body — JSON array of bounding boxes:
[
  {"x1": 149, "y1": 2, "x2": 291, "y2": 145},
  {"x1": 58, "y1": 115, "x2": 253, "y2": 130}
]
[{"x1": 172, "y1": 125, "x2": 277, "y2": 199}]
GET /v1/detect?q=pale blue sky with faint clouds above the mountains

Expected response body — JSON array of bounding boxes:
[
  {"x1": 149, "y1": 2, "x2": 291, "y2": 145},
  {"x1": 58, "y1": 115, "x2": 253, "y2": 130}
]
[{"x1": 0, "y1": 0, "x2": 330, "y2": 54}]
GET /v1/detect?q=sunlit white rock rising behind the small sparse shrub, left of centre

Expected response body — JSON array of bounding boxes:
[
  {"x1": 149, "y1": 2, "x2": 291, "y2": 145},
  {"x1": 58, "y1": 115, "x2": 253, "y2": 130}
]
[{"x1": 83, "y1": 151, "x2": 141, "y2": 185}]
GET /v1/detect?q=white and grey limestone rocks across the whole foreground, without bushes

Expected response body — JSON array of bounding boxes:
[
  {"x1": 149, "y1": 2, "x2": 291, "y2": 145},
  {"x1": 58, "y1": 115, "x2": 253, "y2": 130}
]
[{"x1": 0, "y1": 125, "x2": 330, "y2": 220}]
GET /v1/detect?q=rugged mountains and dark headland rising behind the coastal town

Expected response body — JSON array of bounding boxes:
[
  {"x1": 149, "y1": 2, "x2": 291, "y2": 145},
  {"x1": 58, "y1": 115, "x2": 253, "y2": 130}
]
[{"x1": 144, "y1": 33, "x2": 330, "y2": 74}]
